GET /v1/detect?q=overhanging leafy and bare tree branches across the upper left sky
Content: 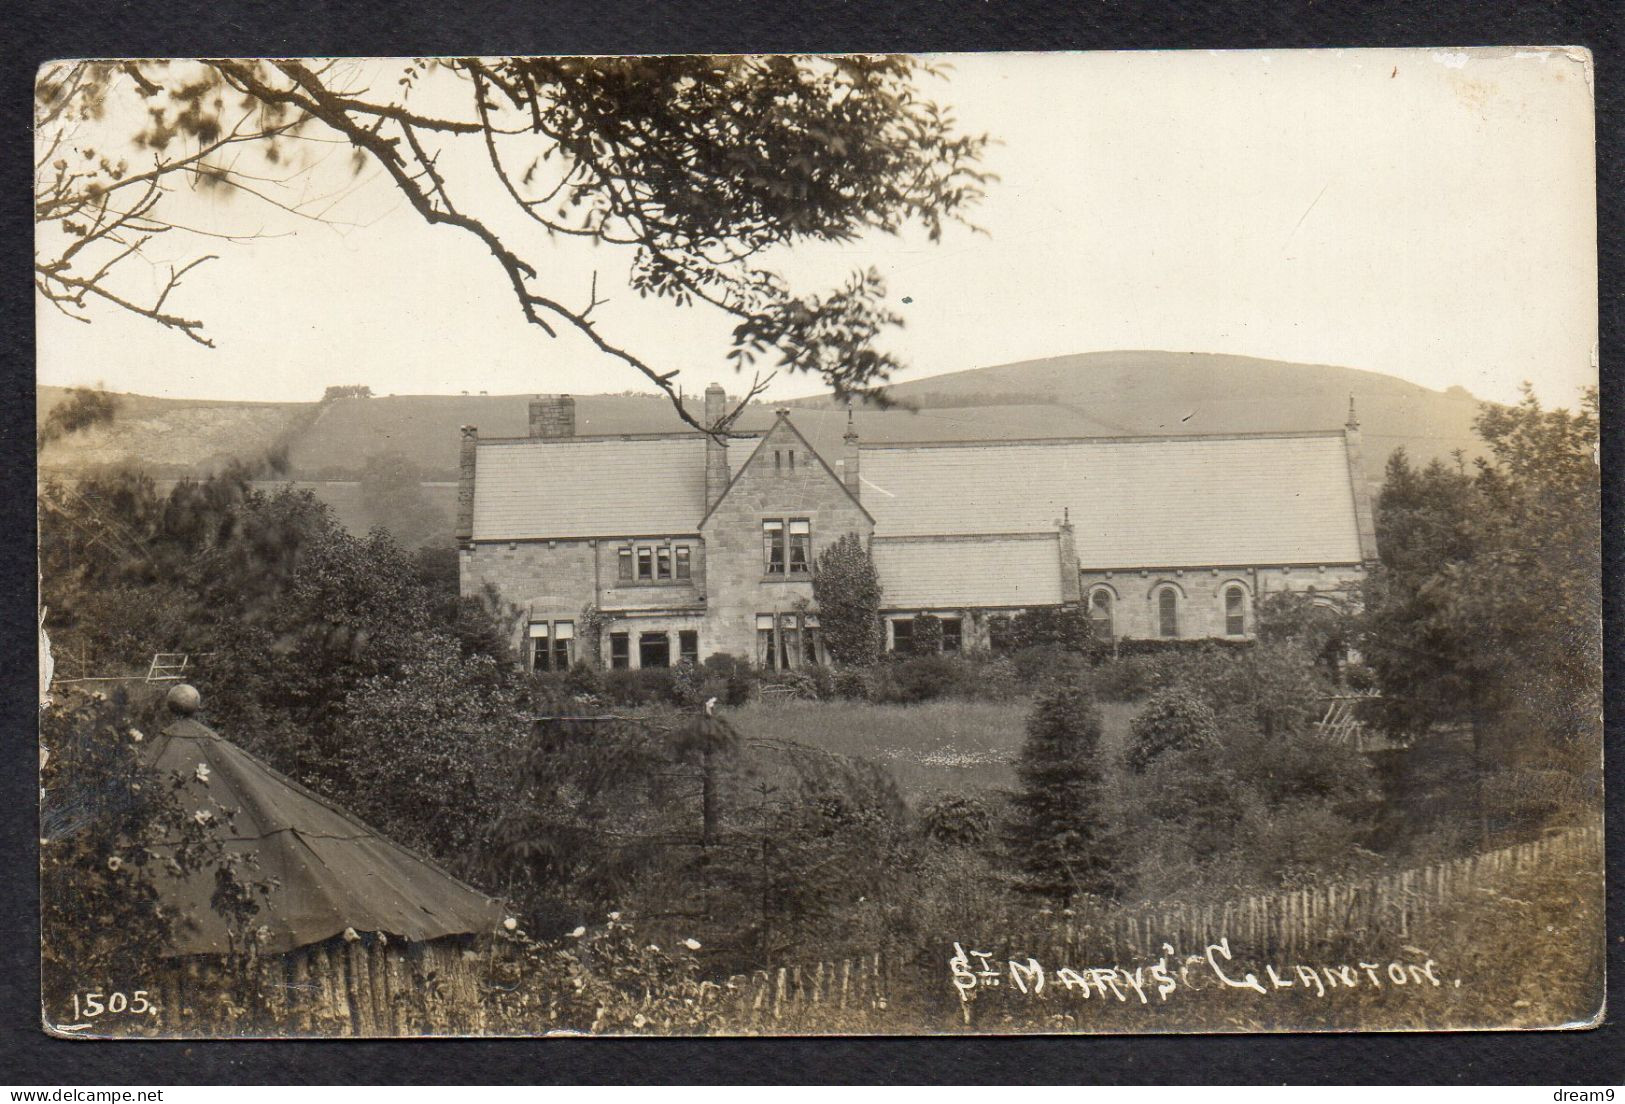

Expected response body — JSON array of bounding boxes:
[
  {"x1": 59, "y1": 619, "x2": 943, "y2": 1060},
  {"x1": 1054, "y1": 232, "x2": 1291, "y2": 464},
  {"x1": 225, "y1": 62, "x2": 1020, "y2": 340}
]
[{"x1": 34, "y1": 55, "x2": 988, "y2": 432}]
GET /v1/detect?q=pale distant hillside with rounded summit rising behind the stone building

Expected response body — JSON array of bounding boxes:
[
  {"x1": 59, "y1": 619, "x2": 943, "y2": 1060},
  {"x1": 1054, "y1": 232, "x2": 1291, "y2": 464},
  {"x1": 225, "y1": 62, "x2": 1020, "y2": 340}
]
[{"x1": 37, "y1": 351, "x2": 1480, "y2": 530}]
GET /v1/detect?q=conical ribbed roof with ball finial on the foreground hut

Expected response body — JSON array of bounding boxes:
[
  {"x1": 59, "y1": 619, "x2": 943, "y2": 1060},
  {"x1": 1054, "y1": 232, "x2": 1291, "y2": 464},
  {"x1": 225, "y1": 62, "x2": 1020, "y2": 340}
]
[{"x1": 148, "y1": 686, "x2": 502, "y2": 956}]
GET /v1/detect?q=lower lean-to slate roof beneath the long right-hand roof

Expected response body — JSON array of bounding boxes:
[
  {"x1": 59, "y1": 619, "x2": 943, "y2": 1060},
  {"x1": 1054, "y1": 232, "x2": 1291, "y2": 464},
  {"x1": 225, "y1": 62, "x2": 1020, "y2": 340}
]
[{"x1": 873, "y1": 533, "x2": 1061, "y2": 610}]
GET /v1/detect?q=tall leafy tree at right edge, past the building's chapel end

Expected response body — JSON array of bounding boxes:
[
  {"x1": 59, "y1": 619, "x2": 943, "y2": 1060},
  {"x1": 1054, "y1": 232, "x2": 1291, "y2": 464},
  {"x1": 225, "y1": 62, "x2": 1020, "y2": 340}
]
[{"x1": 1362, "y1": 387, "x2": 1602, "y2": 777}]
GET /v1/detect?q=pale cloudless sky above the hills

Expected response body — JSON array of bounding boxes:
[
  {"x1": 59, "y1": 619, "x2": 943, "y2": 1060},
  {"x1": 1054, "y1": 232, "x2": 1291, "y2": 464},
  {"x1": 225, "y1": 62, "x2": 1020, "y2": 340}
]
[{"x1": 37, "y1": 50, "x2": 1597, "y2": 405}]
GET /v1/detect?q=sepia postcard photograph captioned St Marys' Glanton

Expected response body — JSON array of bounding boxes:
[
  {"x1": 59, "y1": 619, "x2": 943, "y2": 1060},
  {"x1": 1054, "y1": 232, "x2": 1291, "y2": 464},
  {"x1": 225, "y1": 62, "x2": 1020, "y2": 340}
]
[{"x1": 31, "y1": 46, "x2": 1606, "y2": 1045}]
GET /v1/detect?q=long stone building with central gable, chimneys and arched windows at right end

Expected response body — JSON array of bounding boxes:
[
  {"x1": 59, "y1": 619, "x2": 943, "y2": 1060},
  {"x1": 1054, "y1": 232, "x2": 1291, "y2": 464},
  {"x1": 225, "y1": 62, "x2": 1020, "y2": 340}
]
[{"x1": 457, "y1": 384, "x2": 1376, "y2": 670}]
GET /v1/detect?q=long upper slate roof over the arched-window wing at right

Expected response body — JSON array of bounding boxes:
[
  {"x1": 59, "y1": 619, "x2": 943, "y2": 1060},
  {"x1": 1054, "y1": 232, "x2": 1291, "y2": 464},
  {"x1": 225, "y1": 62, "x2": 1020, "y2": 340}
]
[{"x1": 861, "y1": 432, "x2": 1362, "y2": 569}]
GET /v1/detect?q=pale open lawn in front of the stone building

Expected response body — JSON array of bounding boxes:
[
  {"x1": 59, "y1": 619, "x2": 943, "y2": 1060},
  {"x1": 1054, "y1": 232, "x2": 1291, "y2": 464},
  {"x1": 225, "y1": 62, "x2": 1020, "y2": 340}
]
[{"x1": 730, "y1": 699, "x2": 1134, "y2": 802}]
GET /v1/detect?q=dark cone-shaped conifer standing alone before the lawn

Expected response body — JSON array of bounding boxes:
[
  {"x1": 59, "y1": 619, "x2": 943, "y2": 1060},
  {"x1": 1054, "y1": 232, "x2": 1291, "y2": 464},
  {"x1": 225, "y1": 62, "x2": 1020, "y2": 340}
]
[{"x1": 1006, "y1": 688, "x2": 1120, "y2": 904}]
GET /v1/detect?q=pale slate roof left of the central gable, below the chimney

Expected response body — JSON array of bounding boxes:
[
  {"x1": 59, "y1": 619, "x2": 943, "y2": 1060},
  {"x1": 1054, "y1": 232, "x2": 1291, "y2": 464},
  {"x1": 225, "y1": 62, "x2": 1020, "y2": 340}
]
[{"x1": 473, "y1": 434, "x2": 705, "y2": 540}]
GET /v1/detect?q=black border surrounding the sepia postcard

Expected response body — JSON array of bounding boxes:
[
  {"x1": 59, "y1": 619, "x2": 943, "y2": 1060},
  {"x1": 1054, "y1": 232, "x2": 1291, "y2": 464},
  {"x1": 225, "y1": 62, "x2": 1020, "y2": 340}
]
[{"x1": 0, "y1": 0, "x2": 1625, "y2": 1086}]
